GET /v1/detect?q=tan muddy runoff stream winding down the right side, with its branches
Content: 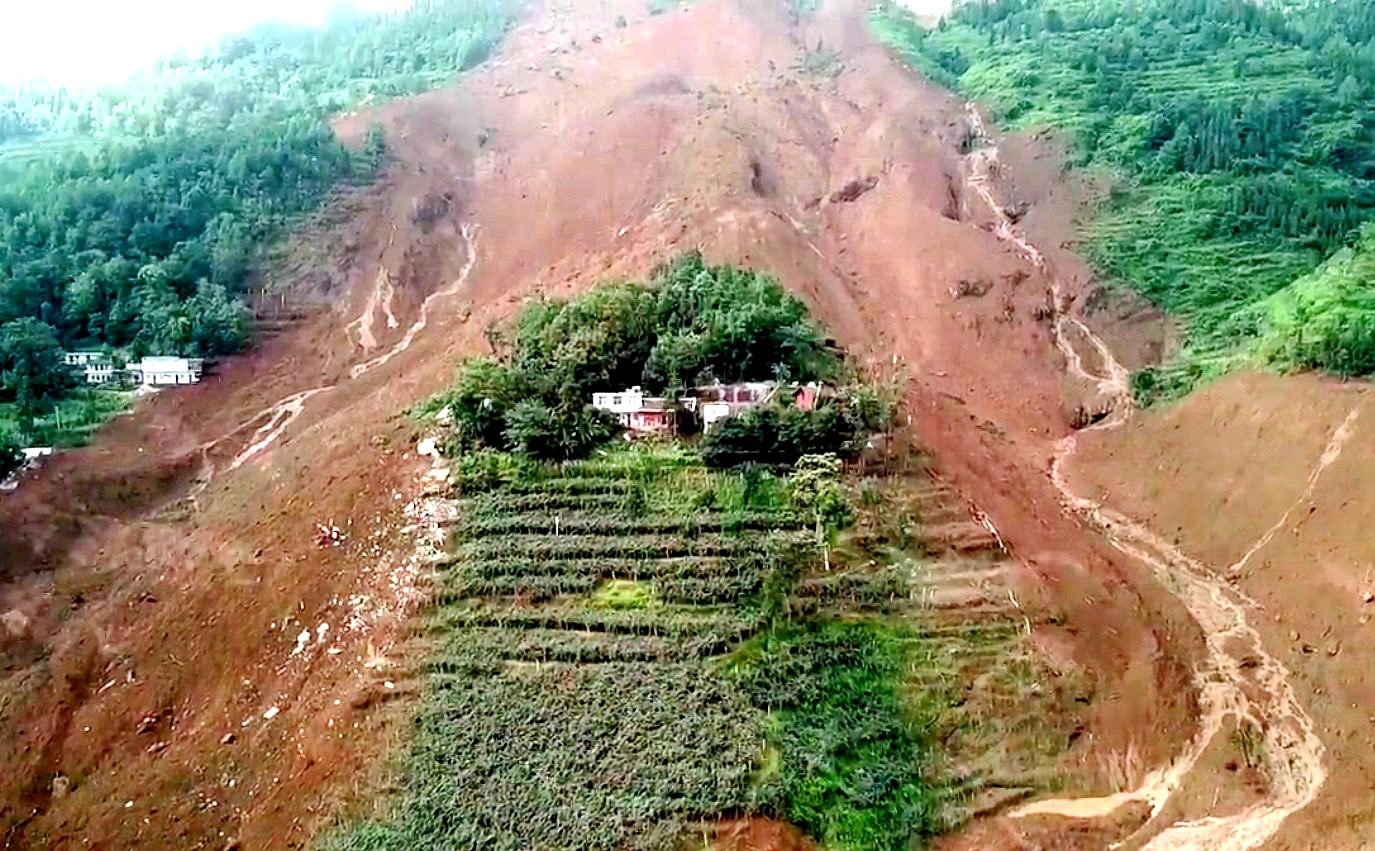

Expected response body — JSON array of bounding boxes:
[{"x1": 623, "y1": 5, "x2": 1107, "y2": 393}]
[{"x1": 965, "y1": 106, "x2": 1342, "y2": 851}]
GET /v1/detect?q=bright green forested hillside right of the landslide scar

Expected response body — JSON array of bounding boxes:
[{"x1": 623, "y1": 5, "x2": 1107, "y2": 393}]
[{"x1": 875, "y1": 0, "x2": 1375, "y2": 397}]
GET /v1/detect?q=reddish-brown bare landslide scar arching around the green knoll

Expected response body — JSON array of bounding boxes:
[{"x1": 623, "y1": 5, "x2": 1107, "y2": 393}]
[{"x1": 8, "y1": 0, "x2": 1353, "y2": 848}]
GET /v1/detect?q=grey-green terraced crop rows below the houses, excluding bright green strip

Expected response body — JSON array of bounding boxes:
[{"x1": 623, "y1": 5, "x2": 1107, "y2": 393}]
[{"x1": 323, "y1": 462, "x2": 815, "y2": 850}]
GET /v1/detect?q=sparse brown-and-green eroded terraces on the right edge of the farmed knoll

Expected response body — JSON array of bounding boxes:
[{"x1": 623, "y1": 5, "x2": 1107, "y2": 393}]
[{"x1": 825, "y1": 478, "x2": 1086, "y2": 824}]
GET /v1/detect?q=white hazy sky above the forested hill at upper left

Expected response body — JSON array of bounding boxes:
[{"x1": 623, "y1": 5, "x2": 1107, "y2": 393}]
[{"x1": 0, "y1": 0, "x2": 410, "y2": 85}]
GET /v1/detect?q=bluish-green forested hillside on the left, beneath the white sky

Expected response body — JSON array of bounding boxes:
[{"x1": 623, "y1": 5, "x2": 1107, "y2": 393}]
[{"x1": 0, "y1": 0, "x2": 512, "y2": 425}]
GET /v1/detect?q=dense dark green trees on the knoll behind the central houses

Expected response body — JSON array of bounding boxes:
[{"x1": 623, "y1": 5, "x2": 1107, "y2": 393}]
[{"x1": 437, "y1": 253, "x2": 854, "y2": 461}]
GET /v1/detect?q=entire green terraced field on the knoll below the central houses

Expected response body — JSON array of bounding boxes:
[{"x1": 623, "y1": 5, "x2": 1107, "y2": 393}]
[{"x1": 324, "y1": 451, "x2": 1072, "y2": 850}]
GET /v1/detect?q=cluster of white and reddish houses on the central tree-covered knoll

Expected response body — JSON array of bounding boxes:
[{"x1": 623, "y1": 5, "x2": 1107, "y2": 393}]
[{"x1": 593, "y1": 381, "x2": 821, "y2": 434}]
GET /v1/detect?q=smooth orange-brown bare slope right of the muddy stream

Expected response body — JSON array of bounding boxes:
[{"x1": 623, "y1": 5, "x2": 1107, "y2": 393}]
[{"x1": 1075, "y1": 374, "x2": 1375, "y2": 851}]
